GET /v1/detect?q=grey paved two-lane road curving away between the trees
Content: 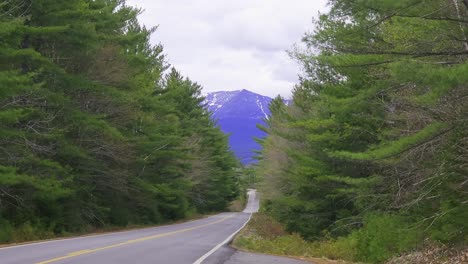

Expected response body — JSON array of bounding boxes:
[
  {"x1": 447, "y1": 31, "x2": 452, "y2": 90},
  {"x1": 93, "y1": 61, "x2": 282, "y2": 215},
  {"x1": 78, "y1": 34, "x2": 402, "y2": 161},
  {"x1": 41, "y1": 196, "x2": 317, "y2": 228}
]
[{"x1": 0, "y1": 190, "x2": 258, "y2": 264}]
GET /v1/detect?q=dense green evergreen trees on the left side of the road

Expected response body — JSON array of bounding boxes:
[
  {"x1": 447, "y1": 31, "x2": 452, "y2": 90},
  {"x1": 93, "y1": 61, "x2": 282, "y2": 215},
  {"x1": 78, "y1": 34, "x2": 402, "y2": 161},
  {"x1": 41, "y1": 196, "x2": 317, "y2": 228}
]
[{"x1": 0, "y1": 0, "x2": 240, "y2": 243}]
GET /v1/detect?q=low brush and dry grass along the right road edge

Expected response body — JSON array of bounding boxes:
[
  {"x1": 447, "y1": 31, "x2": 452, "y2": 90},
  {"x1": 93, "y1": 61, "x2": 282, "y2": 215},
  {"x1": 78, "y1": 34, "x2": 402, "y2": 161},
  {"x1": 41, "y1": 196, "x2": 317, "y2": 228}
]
[{"x1": 236, "y1": 213, "x2": 468, "y2": 264}]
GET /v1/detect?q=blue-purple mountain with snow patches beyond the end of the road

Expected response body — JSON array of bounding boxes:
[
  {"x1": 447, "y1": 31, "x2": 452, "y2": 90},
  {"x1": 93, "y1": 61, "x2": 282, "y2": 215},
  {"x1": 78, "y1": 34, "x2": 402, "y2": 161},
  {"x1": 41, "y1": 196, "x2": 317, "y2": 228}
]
[{"x1": 204, "y1": 90, "x2": 271, "y2": 164}]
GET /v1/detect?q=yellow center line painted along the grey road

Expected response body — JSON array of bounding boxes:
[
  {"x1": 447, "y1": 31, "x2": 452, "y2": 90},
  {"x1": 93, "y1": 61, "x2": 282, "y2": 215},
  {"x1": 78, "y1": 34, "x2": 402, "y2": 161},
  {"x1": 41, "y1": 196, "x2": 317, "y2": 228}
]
[{"x1": 36, "y1": 214, "x2": 234, "y2": 264}]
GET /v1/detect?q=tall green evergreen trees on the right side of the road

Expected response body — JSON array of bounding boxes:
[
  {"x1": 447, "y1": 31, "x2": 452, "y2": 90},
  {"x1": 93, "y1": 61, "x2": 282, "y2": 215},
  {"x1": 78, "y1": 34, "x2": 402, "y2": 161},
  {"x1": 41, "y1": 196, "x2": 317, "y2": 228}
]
[{"x1": 256, "y1": 0, "x2": 468, "y2": 263}]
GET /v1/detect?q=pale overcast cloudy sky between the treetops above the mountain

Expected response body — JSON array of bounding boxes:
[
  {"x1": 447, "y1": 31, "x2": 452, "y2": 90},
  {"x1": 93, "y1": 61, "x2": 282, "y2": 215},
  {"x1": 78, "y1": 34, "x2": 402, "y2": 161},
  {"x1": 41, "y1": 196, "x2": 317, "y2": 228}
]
[{"x1": 127, "y1": 0, "x2": 326, "y2": 97}]
